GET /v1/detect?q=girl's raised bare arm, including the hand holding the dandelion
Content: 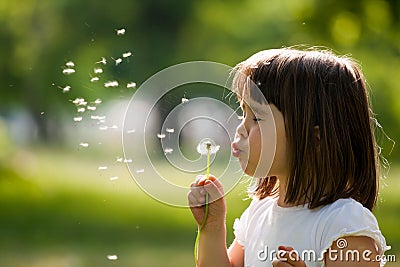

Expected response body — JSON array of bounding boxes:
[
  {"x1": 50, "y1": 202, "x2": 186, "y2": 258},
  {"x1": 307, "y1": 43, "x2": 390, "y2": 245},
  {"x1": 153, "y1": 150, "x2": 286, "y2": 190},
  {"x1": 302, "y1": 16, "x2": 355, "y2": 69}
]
[{"x1": 188, "y1": 176, "x2": 243, "y2": 267}]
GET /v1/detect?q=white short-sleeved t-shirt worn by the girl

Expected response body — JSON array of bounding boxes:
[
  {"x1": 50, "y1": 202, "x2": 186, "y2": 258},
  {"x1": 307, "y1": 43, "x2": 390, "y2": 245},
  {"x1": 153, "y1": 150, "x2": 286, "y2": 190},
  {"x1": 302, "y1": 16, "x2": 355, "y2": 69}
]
[{"x1": 233, "y1": 198, "x2": 390, "y2": 267}]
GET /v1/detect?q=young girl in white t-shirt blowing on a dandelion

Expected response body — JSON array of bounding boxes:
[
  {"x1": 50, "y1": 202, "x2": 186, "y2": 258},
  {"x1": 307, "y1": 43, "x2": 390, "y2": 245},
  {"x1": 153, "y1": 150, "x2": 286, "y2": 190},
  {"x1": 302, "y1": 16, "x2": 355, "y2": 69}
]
[{"x1": 188, "y1": 48, "x2": 388, "y2": 267}]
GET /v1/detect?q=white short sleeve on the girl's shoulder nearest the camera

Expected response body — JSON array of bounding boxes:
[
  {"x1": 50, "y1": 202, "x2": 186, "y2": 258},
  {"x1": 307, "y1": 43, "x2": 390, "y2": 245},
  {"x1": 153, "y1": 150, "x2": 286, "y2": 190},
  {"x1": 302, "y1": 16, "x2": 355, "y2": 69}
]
[{"x1": 320, "y1": 199, "x2": 390, "y2": 266}]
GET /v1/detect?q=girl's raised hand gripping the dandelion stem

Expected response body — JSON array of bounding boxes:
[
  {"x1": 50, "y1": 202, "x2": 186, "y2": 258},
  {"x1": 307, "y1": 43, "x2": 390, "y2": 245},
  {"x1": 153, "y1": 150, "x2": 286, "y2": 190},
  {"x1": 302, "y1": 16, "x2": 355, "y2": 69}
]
[{"x1": 188, "y1": 175, "x2": 226, "y2": 231}]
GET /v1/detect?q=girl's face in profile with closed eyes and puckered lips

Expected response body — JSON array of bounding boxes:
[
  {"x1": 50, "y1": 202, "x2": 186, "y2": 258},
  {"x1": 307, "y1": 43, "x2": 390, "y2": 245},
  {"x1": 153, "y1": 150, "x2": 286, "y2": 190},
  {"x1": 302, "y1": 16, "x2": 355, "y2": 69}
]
[{"x1": 232, "y1": 98, "x2": 288, "y2": 178}]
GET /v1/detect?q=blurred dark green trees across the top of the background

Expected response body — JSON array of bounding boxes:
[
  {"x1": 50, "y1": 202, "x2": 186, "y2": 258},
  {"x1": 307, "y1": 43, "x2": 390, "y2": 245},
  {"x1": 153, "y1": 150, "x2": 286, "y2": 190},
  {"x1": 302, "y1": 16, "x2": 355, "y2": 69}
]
[{"x1": 0, "y1": 0, "x2": 400, "y2": 161}]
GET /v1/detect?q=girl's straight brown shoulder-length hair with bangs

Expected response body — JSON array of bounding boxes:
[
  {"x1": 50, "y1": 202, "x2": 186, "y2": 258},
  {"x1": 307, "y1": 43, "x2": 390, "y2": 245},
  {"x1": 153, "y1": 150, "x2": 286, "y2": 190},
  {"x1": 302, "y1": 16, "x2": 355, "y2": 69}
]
[{"x1": 232, "y1": 48, "x2": 379, "y2": 210}]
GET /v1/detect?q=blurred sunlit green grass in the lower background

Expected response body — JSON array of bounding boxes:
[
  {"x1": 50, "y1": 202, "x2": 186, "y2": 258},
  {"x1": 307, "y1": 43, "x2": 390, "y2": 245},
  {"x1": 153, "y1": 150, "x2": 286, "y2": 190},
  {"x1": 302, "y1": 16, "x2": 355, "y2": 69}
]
[{"x1": 0, "y1": 149, "x2": 400, "y2": 267}]
